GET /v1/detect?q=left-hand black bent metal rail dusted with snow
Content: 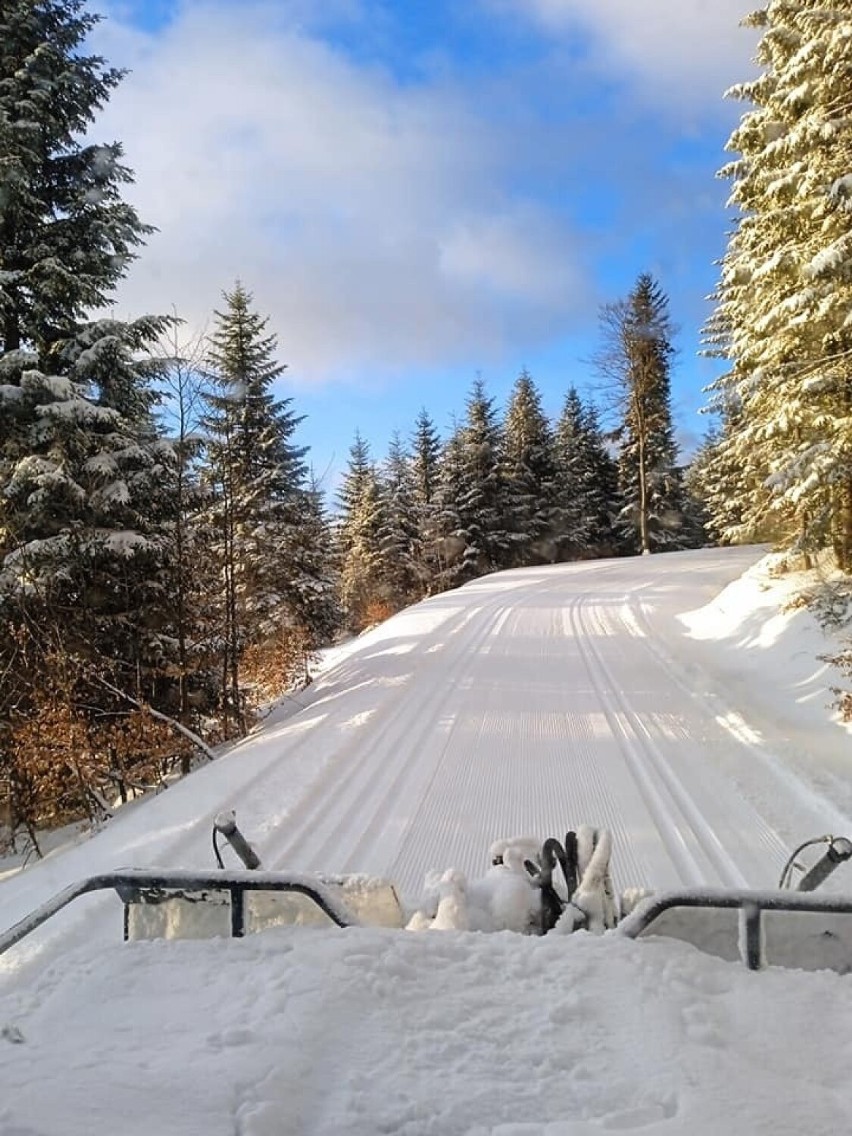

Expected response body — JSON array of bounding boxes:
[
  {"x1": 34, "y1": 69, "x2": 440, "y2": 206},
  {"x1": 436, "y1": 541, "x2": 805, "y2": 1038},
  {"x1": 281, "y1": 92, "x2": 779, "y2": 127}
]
[{"x1": 0, "y1": 868, "x2": 358, "y2": 954}]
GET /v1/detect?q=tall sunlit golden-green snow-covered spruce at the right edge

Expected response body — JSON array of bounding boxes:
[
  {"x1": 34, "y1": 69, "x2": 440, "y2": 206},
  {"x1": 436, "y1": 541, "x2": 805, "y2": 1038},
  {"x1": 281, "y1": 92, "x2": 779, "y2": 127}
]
[{"x1": 707, "y1": 0, "x2": 852, "y2": 570}]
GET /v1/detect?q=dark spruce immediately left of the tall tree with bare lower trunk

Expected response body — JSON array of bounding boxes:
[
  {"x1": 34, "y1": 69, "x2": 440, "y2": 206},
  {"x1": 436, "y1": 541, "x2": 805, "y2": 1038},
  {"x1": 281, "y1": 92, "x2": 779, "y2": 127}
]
[{"x1": 554, "y1": 387, "x2": 620, "y2": 560}]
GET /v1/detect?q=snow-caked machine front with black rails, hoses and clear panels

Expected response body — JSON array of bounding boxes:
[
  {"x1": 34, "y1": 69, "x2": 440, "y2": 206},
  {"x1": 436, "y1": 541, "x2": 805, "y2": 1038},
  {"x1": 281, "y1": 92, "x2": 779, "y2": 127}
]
[{"x1": 0, "y1": 813, "x2": 852, "y2": 972}]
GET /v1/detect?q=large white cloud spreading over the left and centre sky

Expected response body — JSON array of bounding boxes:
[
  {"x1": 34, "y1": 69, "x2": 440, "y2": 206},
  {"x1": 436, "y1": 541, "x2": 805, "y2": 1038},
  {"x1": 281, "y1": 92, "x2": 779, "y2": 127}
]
[{"x1": 97, "y1": 2, "x2": 587, "y2": 381}]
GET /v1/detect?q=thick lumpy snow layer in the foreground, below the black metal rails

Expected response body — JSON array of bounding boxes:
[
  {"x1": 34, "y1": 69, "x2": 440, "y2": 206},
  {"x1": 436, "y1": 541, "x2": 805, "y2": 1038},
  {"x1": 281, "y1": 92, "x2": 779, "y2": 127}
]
[{"x1": 0, "y1": 929, "x2": 852, "y2": 1136}]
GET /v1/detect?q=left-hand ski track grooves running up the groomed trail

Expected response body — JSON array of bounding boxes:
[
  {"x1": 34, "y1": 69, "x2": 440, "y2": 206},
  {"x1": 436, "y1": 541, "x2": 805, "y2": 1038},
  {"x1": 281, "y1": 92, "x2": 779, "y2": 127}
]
[{"x1": 274, "y1": 595, "x2": 518, "y2": 871}]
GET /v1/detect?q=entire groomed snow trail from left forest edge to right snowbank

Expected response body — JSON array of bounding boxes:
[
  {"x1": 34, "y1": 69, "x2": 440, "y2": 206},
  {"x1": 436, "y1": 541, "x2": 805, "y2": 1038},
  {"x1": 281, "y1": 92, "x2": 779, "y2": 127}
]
[{"x1": 0, "y1": 549, "x2": 852, "y2": 966}]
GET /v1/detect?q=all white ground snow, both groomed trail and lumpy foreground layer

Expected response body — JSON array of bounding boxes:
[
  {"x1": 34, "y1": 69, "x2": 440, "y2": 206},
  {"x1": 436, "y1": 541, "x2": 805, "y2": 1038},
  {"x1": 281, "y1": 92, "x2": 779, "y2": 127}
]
[{"x1": 0, "y1": 549, "x2": 852, "y2": 1136}]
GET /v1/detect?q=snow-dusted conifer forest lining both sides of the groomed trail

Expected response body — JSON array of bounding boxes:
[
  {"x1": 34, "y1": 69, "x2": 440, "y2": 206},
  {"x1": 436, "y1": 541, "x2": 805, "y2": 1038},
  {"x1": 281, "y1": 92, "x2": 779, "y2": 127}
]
[{"x1": 0, "y1": 0, "x2": 852, "y2": 852}]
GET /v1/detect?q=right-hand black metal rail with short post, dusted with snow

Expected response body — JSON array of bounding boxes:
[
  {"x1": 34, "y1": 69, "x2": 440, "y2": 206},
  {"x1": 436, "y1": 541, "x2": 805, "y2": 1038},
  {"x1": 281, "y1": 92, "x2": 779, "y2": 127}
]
[{"x1": 618, "y1": 887, "x2": 852, "y2": 970}]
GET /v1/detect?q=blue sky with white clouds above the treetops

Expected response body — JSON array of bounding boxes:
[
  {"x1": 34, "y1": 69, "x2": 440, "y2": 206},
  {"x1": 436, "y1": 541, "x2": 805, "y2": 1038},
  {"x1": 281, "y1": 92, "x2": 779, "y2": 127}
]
[{"x1": 92, "y1": 0, "x2": 755, "y2": 487}]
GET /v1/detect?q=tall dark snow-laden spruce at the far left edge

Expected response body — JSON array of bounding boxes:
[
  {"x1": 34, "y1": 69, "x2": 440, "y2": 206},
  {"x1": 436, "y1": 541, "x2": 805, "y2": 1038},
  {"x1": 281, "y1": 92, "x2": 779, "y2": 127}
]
[{"x1": 0, "y1": 0, "x2": 186, "y2": 836}]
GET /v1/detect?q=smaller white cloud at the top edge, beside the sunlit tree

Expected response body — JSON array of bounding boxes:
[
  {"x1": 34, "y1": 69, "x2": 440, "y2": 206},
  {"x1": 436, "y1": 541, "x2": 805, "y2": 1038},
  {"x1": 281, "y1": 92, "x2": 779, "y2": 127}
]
[{"x1": 486, "y1": 0, "x2": 759, "y2": 115}]
